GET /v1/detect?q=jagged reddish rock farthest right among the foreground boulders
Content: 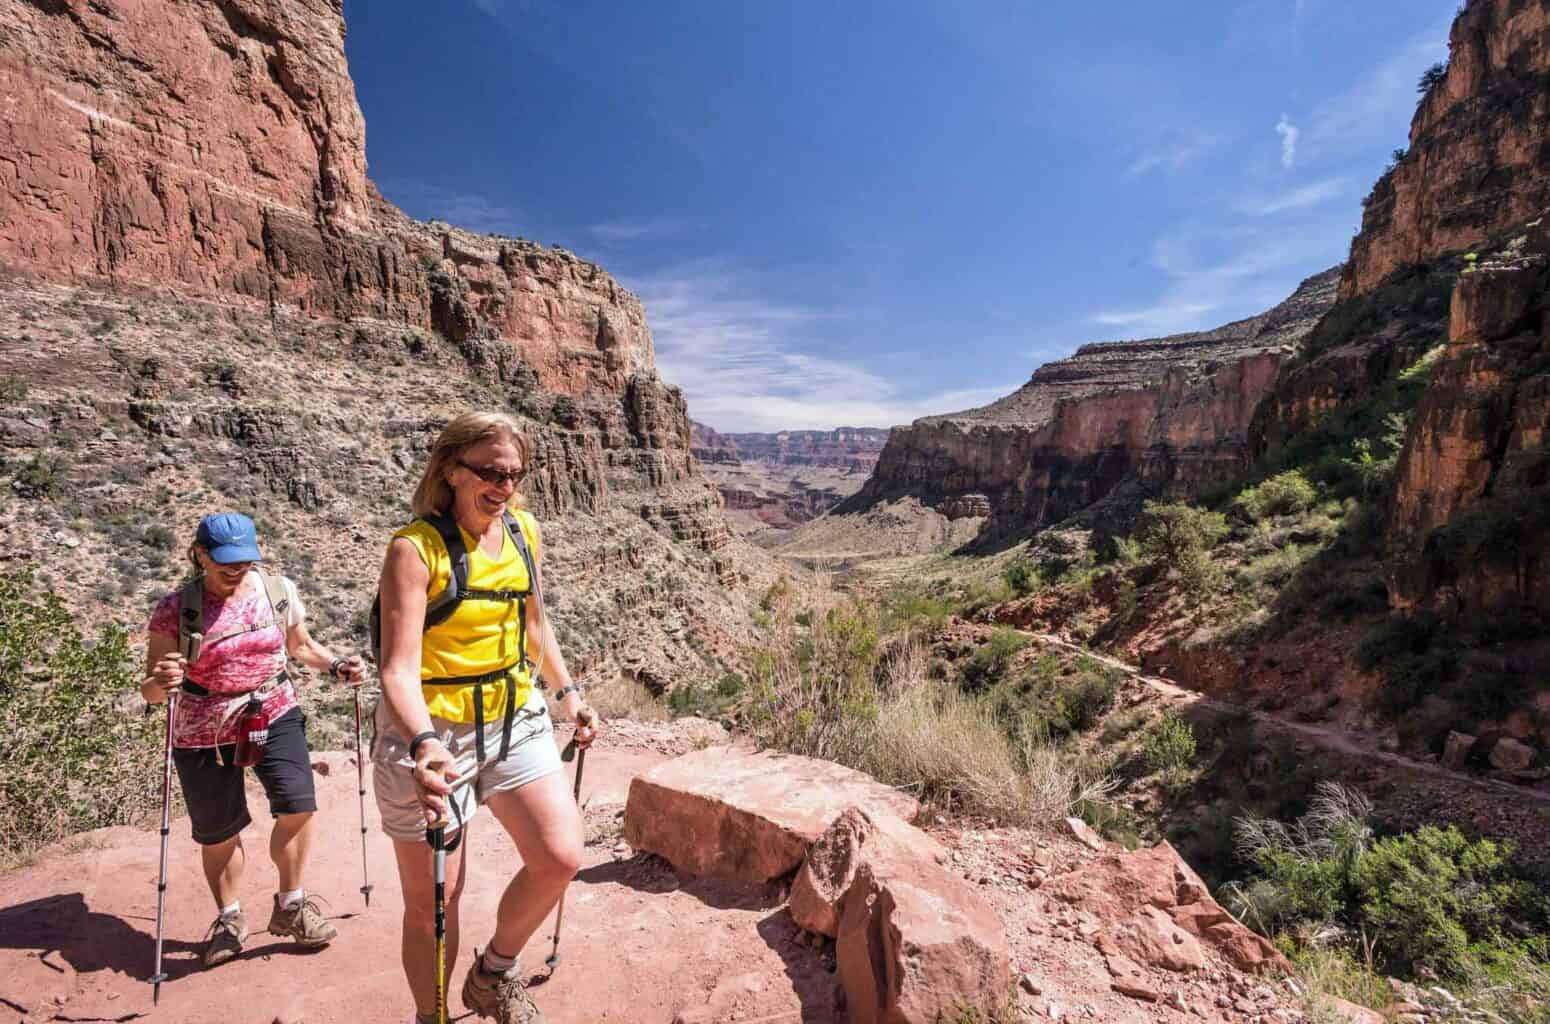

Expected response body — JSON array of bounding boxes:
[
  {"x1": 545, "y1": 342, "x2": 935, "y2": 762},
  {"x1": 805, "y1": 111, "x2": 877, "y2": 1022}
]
[{"x1": 1040, "y1": 843, "x2": 1291, "y2": 971}]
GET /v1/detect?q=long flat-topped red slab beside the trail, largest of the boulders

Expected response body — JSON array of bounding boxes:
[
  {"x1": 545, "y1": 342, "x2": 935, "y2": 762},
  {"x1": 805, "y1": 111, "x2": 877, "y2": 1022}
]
[{"x1": 625, "y1": 747, "x2": 919, "y2": 881}]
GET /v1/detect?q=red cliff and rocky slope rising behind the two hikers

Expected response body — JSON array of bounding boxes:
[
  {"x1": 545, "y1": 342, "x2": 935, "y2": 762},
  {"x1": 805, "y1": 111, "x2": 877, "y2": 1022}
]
[{"x1": 0, "y1": 0, "x2": 763, "y2": 694}]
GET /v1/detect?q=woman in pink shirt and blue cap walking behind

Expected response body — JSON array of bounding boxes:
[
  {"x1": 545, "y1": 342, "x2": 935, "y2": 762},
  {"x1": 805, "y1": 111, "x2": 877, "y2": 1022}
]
[{"x1": 140, "y1": 513, "x2": 364, "y2": 967}]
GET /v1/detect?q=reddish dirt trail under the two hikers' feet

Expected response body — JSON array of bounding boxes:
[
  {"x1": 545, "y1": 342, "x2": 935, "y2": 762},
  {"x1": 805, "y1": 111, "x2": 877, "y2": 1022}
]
[{"x1": 0, "y1": 737, "x2": 839, "y2": 1024}]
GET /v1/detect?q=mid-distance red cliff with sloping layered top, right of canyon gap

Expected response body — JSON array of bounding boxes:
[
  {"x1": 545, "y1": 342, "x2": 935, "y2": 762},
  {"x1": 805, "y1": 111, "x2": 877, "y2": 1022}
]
[{"x1": 840, "y1": 270, "x2": 1338, "y2": 527}]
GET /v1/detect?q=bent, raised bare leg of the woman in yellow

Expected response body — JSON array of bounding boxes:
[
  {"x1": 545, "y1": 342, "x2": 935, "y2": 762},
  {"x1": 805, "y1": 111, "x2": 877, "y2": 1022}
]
[{"x1": 487, "y1": 771, "x2": 581, "y2": 956}]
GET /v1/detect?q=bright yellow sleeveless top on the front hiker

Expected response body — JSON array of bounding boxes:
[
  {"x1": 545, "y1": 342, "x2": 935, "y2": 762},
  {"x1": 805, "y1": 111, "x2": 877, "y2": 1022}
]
[{"x1": 394, "y1": 510, "x2": 539, "y2": 722}]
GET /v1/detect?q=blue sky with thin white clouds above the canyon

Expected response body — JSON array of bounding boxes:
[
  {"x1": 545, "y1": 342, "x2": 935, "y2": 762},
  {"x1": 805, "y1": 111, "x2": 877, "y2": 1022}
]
[{"x1": 346, "y1": 0, "x2": 1457, "y2": 431}]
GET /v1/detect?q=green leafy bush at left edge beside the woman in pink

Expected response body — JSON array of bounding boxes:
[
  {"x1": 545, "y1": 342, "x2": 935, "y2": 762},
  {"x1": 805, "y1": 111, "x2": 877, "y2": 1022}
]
[{"x1": 0, "y1": 572, "x2": 164, "y2": 857}]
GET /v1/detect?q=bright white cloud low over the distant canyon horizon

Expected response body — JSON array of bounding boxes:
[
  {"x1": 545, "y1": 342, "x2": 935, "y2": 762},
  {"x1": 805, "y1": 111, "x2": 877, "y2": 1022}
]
[{"x1": 625, "y1": 265, "x2": 1009, "y2": 431}]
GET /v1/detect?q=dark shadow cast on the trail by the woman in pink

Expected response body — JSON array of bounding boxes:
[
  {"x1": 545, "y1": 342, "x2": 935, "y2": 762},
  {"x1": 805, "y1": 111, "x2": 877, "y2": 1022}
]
[{"x1": 0, "y1": 892, "x2": 350, "y2": 982}]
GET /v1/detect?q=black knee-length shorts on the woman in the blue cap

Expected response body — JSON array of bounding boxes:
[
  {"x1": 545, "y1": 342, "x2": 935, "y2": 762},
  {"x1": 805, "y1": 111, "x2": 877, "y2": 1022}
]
[{"x1": 172, "y1": 708, "x2": 318, "y2": 846}]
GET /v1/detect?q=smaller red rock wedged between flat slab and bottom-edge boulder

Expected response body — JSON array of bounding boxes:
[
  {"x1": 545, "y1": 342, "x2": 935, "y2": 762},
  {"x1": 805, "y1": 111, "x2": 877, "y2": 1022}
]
[{"x1": 791, "y1": 807, "x2": 947, "y2": 937}]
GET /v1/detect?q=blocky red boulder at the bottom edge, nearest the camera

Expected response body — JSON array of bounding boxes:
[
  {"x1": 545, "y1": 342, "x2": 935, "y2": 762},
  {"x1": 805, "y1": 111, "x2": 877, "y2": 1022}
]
[{"x1": 835, "y1": 858, "x2": 1012, "y2": 1024}]
